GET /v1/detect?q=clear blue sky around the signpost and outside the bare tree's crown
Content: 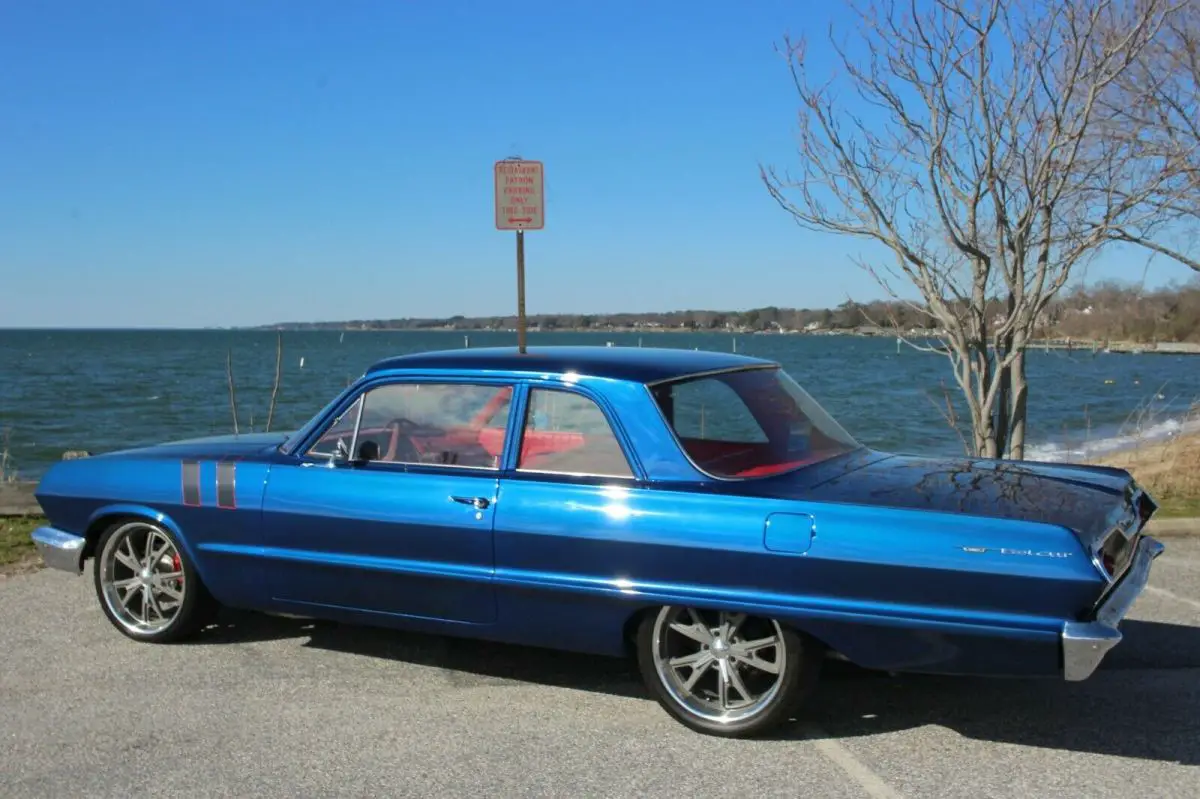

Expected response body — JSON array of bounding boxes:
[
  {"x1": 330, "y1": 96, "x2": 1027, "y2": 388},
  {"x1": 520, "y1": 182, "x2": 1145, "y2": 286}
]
[{"x1": 0, "y1": 0, "x2": 1190, "y2": 326}]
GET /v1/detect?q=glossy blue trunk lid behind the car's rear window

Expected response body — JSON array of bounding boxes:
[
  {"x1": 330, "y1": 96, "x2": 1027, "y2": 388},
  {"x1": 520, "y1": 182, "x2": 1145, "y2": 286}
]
[{"x1": 748, "y1": 452, "x2": 1153, "y2": 542}]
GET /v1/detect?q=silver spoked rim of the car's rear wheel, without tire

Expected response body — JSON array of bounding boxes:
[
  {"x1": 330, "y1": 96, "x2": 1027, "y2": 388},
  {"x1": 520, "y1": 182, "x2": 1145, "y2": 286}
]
[{"x1": 653, "y1": 606, "x2": 787, "y2": 723}]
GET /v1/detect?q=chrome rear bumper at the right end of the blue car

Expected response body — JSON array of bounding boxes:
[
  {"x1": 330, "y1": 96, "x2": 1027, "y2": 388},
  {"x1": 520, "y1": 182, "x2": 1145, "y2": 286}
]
[{"x1": 1062, "y1": 536, "x2": 1164, "y2": 681}]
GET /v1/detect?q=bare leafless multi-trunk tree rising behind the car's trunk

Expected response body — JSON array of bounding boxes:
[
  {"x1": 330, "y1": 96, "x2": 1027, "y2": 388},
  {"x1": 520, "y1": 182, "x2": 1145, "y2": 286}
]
[{"x1": 762, "y1": 0, "x2": 1187, "y2": 458}]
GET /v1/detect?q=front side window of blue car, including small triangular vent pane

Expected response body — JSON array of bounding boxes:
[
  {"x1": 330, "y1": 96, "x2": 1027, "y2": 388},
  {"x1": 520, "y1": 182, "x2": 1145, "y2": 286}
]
[{"x1": 304, "y1": 383, "x2": 512, "y2": 469}]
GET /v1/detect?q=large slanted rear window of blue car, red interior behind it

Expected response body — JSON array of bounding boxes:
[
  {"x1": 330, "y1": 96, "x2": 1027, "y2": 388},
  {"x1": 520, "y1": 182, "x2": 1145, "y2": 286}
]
[{"x1": 650, "y1": 368, "x2": 860, "y2": 477}]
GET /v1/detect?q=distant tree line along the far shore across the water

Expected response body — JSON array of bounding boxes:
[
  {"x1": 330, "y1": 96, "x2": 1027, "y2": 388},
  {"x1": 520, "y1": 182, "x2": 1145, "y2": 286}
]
[{"x1": 260, "y1": 277, "x2": 1200, "y2": 342}]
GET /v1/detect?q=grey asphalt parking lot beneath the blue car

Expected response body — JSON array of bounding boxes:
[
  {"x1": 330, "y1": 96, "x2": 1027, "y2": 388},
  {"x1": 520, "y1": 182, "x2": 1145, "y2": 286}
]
[{"x1": 0, "y1": 539, "x2": 1200, "y2": 799}]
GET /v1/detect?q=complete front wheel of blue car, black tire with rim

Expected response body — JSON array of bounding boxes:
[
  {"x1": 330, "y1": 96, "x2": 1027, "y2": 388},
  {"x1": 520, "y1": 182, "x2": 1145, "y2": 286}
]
[{"x1": 95, "y1": 519, "x2": 216, "y2": 643}]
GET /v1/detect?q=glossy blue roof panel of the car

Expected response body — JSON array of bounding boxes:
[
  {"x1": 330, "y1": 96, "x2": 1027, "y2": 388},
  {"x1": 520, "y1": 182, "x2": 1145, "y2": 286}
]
[{"x1": 367, "y1": 347, "x2": 778, "y2": 383}]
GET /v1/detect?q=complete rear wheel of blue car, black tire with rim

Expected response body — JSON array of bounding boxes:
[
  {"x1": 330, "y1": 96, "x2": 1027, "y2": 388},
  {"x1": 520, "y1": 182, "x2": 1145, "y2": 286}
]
[{"x1": 637, "y1": 606, "x2": 822, "y2": 738}]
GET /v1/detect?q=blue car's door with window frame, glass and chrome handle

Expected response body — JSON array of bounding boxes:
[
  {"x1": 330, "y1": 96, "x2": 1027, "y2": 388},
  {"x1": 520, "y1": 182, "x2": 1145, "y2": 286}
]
[{"x1": 263, "y1": 378, "x2": 512, "y2": 624}]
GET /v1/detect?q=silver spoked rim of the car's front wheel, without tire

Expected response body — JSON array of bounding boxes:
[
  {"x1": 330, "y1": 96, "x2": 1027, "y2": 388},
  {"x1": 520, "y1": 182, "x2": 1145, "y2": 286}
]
[{"x1": 100, "y1": 522, "x2": 186, "y2": 635}]
